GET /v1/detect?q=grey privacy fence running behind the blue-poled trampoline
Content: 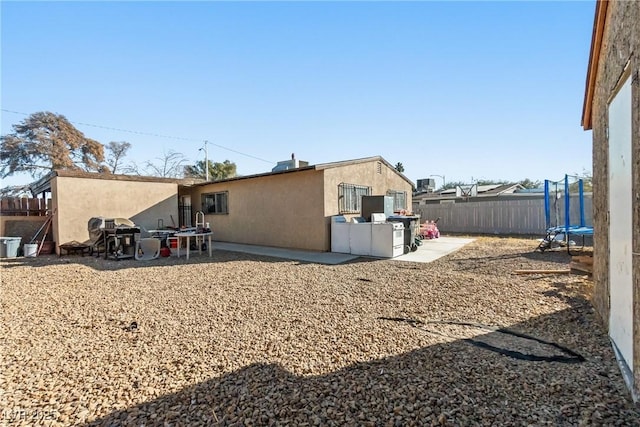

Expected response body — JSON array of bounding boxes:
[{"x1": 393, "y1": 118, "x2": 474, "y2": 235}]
[{"x1": 414, "y1": 195, "x2": 593, "y2": 235}]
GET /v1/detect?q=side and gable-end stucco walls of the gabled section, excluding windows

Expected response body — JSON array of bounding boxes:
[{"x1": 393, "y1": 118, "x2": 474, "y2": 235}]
[{"x1": 181, "y1": 161, "x2": 411, "y2": 251}]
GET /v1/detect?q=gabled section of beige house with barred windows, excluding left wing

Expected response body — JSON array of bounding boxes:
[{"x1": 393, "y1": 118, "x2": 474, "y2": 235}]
[{"x1": 185, "y1": 156, "x2": 413, "y2": 251}]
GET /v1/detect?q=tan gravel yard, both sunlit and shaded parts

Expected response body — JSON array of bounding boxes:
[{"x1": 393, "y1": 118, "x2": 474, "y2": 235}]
[{"x1": 0, "y1": 238, "x2": 640, "y2": 426}]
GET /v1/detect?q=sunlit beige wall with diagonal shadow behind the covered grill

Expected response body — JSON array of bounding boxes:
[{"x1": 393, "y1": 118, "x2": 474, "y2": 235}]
[{"x1": 51, "y1": 176, "x2": 178, "y2": 251}]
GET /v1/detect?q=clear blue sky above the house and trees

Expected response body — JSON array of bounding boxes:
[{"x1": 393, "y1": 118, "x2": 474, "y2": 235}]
[{"x1": 1, "y1": 1, "x2": 595, "y2": 189}]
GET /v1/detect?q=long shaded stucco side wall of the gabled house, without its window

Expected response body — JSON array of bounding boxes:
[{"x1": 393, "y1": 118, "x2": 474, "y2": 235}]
[{"x1": 184, "y1": 170, "x2": 328, "y2": 251}]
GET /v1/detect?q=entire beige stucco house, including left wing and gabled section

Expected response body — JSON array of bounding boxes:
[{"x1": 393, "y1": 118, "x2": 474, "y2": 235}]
[{"x1": 17, "y1": 156, "x2": 413, "y2": 253}]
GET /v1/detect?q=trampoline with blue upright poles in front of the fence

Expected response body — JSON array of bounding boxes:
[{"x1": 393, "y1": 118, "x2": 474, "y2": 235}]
[{"x1": 536, "y1": 175, "x2": 593, "y2": 254}]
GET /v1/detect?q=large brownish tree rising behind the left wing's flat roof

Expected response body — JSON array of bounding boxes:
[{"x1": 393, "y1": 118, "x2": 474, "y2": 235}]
[{"x1": 0, "y1": 111, "x2": 109, "y2": 178}]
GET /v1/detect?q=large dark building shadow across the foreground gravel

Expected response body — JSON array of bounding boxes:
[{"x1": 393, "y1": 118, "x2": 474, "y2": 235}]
[{"x1": 88, "y1": 308, "x2": 640, "y2": 426}]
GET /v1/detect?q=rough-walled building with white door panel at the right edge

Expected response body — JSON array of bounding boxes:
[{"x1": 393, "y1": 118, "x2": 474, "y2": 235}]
[{"x1": 582, "y1": 1, "x2": 640, "y2": 400}]
